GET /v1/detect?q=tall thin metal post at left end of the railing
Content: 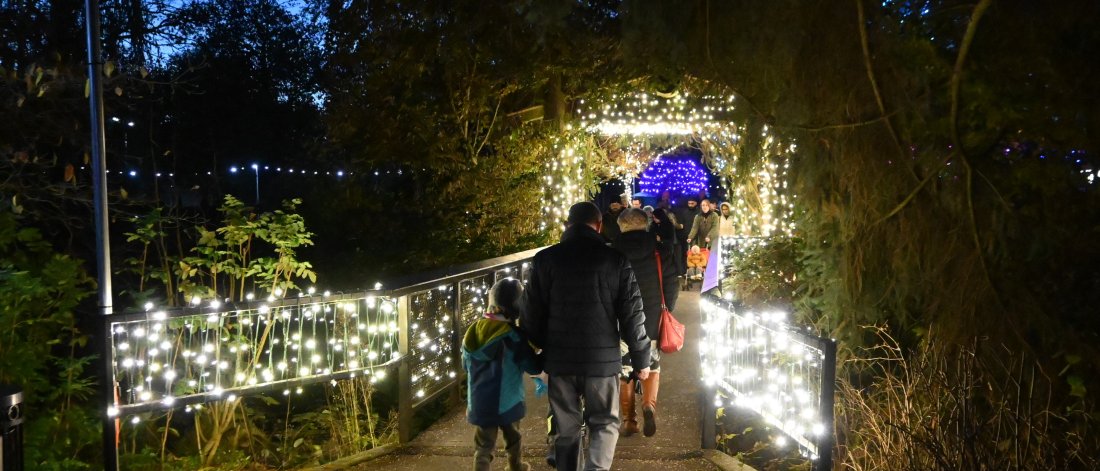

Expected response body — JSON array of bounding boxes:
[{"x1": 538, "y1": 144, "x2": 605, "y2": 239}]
[{"x1": 84, "y1": 0, "x2": 119, "y2": 470}]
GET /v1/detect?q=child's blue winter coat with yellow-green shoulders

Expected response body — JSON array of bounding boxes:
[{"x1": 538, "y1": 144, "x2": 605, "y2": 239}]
[{"x1": 462, "y1": 318, "x2": 542, "y2": 427}]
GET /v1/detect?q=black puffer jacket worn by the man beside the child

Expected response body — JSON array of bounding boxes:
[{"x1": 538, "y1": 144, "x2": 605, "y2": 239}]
[{"x1": 519, "y1": 224, "x2": 650, "y2": 376}]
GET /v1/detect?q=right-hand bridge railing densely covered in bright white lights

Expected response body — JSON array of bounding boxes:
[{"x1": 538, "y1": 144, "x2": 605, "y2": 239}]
[{"x1": 700, "y1": 238, "x2": 836, "y2": 470}]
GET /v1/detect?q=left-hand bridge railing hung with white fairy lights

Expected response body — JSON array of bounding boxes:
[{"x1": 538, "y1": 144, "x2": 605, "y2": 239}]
[{"x1": 105, "y1": 250, "x2": 537, "y2": 453}]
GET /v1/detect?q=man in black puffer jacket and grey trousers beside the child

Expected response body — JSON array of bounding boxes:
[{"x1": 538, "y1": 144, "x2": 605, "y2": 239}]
[{"x1": 520, "y1": 202, "x2": 650, "y2": 471}]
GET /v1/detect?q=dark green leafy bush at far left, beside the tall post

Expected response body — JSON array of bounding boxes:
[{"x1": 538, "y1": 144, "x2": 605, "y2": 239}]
[{"x1": 0, "y1": 211, "x2": 99, "y2": 470}]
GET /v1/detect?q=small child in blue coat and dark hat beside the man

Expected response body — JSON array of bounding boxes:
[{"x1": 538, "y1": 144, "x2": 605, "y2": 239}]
[{"x1": 462, "y1": 278, "x2": 542, "y2": 471}]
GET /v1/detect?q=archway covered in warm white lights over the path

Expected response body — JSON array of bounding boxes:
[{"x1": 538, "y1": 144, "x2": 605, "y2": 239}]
[{"x1": 543, "y1": 86, "x2": 798, "y2": 237}]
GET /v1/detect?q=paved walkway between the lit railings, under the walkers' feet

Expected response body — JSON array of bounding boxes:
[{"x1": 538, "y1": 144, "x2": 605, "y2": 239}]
[{"x1": 352, "y1": 292, "x2": 721, "y2": 471}]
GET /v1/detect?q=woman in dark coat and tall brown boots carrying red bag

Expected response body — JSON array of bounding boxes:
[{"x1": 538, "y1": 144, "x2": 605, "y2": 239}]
[{"x1": 612, "y1": 208, "x2": 680, "y2": 437}]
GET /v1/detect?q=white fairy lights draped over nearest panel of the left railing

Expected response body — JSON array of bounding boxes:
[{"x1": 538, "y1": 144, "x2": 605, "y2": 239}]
[{"x1": 110, "y1": 295, "x2": 399, "y2": 414}]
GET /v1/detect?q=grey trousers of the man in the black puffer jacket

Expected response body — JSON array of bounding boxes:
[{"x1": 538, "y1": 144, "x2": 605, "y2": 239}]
[{"x1": 549, "y1": 374, "x2": 619, "y2": 471}]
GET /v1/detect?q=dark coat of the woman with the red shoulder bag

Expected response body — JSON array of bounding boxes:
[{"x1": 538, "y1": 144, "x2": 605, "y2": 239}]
[{"x1": 612, "y1": 231, "x2": 680, "y2": 339}]
